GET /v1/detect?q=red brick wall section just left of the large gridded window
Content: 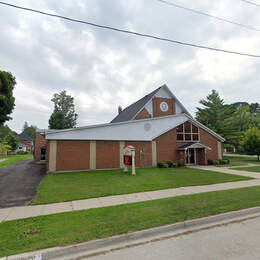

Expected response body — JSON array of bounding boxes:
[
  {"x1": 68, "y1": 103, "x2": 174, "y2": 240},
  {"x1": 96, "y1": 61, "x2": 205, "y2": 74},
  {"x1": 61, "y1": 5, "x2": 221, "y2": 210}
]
[{"x1": 155, "y1": 129, "x2": 179, "y2": 162}]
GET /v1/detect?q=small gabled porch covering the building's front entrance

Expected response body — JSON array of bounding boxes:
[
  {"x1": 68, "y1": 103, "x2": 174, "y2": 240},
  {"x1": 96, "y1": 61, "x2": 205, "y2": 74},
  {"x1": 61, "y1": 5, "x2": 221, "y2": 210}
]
[{"x1": 177, "y1": 142, "x2": 211, "y2": 165}]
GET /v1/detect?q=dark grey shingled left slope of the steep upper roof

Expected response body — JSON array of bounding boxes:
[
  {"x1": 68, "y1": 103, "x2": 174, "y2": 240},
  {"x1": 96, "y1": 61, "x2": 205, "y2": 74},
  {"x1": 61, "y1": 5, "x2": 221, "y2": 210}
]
[{"x1": 110, "y1": 86, "x2": 162, "y2": 123}]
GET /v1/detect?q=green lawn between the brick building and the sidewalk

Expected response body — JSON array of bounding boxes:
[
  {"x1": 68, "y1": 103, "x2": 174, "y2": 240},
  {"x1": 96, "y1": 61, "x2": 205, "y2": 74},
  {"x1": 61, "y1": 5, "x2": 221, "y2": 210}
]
[{"x1": 33, "y1": 168, "x2": 250, "y2": 204}]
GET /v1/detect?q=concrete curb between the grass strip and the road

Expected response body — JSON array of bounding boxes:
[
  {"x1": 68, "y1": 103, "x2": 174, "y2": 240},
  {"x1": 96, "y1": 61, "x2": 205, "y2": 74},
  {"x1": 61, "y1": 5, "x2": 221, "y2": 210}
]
[{"x1": 5, "y1": 207, "x2": 260, "y2": 260}]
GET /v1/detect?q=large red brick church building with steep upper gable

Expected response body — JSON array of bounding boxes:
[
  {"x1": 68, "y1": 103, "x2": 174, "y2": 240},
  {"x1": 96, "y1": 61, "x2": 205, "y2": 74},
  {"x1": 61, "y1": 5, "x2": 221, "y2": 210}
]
[{"x1": 35, "y1": 85, "x2": 224, "y2": 172}]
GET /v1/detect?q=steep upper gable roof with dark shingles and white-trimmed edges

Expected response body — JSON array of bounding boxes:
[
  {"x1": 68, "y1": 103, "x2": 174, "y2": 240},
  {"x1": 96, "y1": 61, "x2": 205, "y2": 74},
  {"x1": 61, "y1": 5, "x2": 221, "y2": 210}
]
[{"x1": 110, "y1": 84, "x2": 191, "y2": 123}]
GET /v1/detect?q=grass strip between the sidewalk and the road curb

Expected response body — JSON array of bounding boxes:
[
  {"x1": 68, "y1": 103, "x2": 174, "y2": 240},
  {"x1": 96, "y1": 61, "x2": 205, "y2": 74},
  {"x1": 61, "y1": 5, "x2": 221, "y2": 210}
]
[{"x1": 0, "y1": 186, "x2": 260, "y2": 257}]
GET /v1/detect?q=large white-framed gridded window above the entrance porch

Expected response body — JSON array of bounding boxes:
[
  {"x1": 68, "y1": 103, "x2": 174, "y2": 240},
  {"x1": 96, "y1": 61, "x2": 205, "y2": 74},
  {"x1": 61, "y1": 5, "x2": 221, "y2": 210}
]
[{"x1": 177, "y1": 122, "x2": 200, "y2": 142}]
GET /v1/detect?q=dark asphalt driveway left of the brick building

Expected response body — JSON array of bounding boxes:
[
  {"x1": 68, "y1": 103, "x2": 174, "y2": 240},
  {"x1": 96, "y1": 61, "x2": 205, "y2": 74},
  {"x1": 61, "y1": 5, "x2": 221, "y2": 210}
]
[{"x1": 0, "y1": 159, "x2": 46, "y2": 208}]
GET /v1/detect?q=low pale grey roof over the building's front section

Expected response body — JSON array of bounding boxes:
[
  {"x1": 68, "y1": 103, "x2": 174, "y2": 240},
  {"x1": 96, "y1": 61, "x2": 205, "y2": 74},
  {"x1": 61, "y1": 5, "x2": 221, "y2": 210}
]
[{"x1": 45, "y1": 114, "x2": 225, "y2": 142}]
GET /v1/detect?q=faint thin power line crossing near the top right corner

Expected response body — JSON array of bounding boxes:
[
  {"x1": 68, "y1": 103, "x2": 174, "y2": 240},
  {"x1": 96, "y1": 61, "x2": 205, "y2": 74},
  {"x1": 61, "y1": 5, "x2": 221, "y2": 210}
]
[{"x1": 157, "y1": 0, "x2": 260, "y2": 32}]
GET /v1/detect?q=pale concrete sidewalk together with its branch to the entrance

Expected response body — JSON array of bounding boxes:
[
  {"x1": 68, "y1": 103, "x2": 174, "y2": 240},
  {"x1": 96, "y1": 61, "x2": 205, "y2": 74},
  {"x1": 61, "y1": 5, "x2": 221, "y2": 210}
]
[{"x1": 0, "y1": 166, "x2": 260, "y2": 222}]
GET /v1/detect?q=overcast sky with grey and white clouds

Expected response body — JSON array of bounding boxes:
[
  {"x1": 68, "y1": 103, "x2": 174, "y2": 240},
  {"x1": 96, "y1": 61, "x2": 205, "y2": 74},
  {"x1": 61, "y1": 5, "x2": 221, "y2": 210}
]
[{"x1": 0, "y1": 0, "x2": 260, "y2": 132}]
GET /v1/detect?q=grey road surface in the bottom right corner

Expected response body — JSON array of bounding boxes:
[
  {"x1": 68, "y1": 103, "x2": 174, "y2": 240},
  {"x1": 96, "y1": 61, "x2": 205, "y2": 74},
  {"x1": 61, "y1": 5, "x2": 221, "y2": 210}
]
[{"x1": 89, "y1": 217, "x2": 260, "y2": 260}]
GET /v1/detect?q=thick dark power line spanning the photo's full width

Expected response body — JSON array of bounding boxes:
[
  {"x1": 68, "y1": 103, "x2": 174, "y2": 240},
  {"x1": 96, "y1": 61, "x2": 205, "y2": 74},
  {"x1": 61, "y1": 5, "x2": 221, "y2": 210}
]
[{"x1": 0, "y1": 1, "x2": 260, "y2": 58}]
